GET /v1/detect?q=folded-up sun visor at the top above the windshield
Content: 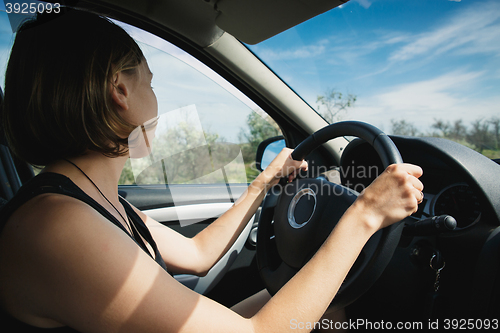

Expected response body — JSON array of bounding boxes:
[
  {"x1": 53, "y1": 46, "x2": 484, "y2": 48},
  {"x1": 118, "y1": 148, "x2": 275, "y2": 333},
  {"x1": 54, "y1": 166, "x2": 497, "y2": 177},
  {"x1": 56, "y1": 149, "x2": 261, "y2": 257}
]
[{"x1": 215, "y1": 0, "x2": 347, "y2": 44}]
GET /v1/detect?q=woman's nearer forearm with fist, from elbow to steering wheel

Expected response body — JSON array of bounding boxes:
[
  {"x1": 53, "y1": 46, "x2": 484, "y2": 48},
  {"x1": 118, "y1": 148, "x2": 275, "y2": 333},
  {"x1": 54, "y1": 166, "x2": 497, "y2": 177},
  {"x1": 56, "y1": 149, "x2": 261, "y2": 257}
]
[{"x1": 252, "y1": 165, "x2": 423, "y2": 332}]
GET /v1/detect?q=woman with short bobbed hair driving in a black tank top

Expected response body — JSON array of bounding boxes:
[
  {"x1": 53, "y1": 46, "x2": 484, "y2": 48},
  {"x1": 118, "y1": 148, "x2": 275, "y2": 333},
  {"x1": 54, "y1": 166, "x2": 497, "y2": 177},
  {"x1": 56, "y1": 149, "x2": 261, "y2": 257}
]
[{"x1": 0, "y1": 10, "x2": 423, "y2": 333}]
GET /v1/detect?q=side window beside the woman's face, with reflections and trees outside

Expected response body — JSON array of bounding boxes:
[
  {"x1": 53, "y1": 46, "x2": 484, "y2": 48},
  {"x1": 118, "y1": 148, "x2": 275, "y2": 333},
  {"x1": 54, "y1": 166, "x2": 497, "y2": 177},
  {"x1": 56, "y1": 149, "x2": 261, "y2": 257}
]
[{"x1": 119, "y1": 23, "x2": 281, "y2": 185}]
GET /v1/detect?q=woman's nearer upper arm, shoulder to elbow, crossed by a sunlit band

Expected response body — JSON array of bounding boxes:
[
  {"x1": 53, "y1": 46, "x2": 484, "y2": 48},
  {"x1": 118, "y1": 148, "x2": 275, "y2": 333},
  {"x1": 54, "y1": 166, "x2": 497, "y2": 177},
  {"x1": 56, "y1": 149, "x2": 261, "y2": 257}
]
[{"x1": 0, "y1": 195, "x2": 250, "y2": 332}]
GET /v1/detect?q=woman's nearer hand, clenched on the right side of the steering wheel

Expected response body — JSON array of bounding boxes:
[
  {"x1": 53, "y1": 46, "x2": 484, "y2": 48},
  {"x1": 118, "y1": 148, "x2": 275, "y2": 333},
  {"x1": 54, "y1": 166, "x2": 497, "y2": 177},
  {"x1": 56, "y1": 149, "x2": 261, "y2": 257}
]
[{"x1": 352, "y1": 164, "x2": 424, "y2": 231}]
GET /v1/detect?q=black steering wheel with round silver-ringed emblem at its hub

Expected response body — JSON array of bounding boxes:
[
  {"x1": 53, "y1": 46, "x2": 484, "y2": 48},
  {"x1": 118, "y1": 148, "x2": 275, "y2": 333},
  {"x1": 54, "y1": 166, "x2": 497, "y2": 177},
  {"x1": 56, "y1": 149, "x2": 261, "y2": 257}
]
[{"x1": 257, "y1": 121, "x2": 404, "y2": 310}]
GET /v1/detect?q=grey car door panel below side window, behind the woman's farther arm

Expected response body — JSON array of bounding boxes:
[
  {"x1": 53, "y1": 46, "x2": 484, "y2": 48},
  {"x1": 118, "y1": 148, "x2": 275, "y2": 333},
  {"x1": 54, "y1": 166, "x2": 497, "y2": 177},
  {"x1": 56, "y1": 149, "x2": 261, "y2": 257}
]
[{"x1": 119, "y1": 184, "x2": 254, "y2": 294}]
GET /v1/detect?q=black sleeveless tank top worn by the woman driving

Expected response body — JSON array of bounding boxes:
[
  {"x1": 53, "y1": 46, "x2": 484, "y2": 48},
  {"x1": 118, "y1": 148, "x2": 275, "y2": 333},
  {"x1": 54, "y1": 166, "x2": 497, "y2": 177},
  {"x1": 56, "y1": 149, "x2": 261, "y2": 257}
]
[{"x1": 0, "y1": 172, "x2": 167, "y2": 333}]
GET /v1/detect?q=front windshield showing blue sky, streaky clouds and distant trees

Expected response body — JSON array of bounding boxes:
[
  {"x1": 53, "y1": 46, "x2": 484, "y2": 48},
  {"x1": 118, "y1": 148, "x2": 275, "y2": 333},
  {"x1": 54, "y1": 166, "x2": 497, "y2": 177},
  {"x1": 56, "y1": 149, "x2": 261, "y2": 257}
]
[{"x1": 248, "y1": 0, "x2": 500, "y2": 158}]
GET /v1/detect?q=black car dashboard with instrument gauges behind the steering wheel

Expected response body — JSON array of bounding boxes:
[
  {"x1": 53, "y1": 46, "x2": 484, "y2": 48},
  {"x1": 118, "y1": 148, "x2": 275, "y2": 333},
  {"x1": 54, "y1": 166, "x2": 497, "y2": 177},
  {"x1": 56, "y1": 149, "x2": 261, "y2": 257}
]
[{"x1": 339, "y1": 136, "x2": 500, "y2": 319}]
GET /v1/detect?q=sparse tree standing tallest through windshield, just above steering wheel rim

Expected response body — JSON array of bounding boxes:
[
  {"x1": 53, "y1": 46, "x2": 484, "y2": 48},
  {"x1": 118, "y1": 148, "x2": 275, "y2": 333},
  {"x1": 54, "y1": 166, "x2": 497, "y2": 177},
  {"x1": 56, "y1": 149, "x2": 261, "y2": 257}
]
[{"x1": 316, "y1": 89, "x2": 357, "y2": 124}]
